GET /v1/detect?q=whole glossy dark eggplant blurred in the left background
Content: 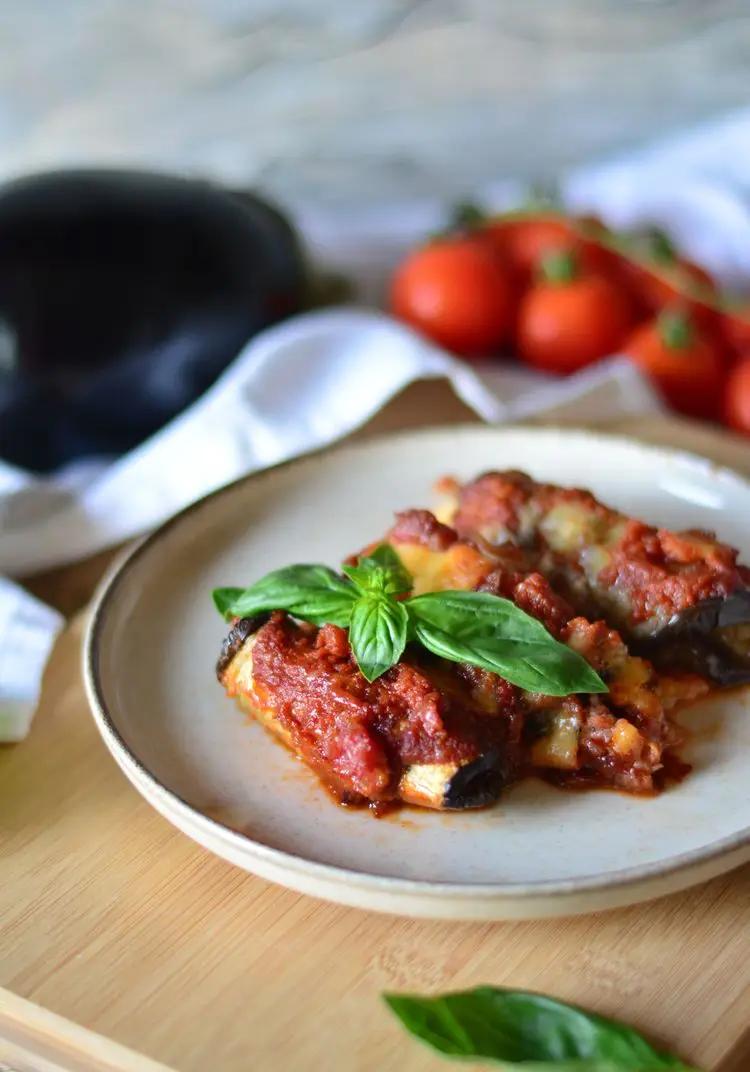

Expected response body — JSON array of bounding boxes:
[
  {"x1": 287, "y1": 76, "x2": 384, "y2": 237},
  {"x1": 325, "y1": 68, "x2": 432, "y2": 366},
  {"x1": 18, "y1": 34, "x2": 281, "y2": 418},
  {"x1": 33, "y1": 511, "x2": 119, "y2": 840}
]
[{"x1": 0, "y1": 169, "x2": 308, "y2": 472}]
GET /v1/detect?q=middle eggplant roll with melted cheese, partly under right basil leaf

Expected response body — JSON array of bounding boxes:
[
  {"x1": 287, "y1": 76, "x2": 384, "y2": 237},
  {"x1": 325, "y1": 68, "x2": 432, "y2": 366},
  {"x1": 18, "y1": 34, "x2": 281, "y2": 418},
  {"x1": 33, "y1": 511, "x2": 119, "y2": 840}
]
[{"x1": 387, "y1": 510, "x2": 709, "y2": 793}]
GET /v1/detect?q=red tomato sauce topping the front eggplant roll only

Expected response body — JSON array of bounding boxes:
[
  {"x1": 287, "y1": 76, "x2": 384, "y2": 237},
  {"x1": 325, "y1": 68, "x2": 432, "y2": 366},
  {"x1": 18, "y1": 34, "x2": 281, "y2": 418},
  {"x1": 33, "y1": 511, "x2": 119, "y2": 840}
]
[{"x1": 248, "y1": 613, "x2": 519, "y2": 801}]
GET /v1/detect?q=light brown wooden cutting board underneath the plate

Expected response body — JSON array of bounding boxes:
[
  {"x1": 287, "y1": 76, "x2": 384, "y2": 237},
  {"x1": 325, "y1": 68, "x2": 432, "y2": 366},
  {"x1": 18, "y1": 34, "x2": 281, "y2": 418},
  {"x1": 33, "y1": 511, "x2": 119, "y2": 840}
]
[{"x1": 0, "y1": 386, "x2": 750, "y2": 1072}]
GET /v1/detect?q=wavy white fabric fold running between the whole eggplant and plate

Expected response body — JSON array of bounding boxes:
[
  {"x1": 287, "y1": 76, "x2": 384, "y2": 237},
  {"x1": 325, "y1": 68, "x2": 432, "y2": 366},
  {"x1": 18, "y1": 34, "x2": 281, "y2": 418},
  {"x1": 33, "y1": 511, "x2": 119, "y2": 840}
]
[{"x1": 0, "y1": 309, "x2": 658, "y2": 576}]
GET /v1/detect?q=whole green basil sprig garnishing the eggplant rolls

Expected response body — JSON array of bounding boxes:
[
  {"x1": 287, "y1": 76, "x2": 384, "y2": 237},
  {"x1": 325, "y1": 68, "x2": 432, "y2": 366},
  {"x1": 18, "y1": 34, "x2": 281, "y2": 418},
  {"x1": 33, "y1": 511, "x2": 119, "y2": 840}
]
[{"x1": 213, "y1": 544, "x2": 606, "y2": 696}]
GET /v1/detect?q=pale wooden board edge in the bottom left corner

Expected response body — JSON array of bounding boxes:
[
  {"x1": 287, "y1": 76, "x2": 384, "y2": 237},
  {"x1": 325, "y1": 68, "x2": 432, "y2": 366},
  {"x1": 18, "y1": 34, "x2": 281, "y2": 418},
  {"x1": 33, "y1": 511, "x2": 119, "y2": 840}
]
[{"x1": 0, "y1": 987, "x2": 175, "y2": 1072}]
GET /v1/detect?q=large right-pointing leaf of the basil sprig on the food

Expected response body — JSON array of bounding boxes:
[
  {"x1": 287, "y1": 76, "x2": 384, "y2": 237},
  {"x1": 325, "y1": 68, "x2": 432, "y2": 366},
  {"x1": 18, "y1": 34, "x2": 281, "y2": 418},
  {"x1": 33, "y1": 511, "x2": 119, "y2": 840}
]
[{"x1": 406, "y1": 591, "x2": 608, "y2": 696}]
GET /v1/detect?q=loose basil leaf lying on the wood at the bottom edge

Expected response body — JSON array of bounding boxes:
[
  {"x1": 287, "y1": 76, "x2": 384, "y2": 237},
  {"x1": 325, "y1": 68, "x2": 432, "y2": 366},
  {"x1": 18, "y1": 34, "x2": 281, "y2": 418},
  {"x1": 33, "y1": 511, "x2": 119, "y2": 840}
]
[{"x1": 384, "y1": 986, "x2": 698, "y2": 1072}]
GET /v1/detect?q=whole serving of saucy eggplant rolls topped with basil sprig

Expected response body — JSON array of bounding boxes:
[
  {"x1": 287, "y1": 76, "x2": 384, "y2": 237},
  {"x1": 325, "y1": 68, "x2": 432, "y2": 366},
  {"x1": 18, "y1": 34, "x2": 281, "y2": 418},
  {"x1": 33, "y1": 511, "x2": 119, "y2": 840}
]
[{"x1": 214, "y1": 482, "x2": 715, "y2": 809}]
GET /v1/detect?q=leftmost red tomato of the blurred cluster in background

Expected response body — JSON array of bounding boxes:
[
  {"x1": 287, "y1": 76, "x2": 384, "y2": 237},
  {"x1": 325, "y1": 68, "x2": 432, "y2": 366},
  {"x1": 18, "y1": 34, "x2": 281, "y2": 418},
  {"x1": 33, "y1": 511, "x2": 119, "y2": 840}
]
[{"x1": 391, "y1": 237, "x2": 512, "y2": 357}]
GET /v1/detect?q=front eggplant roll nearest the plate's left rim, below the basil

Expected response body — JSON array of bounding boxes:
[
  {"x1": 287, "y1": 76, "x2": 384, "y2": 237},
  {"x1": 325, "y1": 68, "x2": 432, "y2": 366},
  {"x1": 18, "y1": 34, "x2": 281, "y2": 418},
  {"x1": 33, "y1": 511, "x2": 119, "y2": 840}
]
[{"x1": 216, "y1": 613, "x2": 512, "y2": 809}]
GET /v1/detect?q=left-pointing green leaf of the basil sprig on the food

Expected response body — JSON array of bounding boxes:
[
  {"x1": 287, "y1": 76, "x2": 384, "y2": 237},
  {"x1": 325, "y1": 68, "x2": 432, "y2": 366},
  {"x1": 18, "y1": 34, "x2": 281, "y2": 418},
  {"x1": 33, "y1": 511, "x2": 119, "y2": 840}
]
[{"x1": 213, "y1": 565, "x2": 357, "y2": 628}]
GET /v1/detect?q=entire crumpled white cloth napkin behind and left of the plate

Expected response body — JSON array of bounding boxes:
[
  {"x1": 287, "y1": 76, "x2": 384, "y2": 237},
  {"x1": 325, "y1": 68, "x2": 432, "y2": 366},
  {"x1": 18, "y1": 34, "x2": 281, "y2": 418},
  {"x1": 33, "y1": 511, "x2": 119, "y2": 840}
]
[{"x1": 7, "y1": 113, "x2": 750, "y2": 740}]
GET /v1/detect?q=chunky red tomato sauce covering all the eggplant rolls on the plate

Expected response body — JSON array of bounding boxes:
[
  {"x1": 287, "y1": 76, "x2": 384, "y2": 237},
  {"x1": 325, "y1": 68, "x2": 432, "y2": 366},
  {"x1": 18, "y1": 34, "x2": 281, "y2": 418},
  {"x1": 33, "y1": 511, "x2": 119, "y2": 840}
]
[{"x1": 219, "y1": 472, "x2": 750, "y2": 813}]
